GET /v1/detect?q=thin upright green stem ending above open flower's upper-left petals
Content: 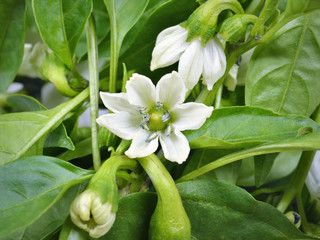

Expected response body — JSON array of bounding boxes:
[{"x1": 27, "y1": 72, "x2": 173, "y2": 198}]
[{"x1": 104, "y1": 0, "x2": 118, "y2": 93}]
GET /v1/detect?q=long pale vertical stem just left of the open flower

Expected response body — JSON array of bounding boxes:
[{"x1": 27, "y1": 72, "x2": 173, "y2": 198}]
[{"x1": 86, "y1": 15, "x2": 101, "y2": 171}]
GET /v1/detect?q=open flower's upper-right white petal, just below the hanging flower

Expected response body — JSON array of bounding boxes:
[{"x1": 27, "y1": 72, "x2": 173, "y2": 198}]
[{"x1": 156, "y1": 72, "x2": 186, "y2": 109}]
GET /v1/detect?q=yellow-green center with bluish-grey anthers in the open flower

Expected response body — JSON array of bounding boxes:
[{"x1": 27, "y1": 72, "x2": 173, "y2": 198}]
[{"x1": 139, "y1": 102, "x2": 172, "y2": 142}]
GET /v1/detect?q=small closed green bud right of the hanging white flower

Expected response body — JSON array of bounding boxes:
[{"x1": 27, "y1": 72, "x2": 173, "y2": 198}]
[{"x1": 219, "y1": 14, "x2": 258, "y2": 44}]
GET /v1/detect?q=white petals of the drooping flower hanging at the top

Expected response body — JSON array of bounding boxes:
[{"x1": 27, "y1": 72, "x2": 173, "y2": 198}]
[{"x1": 150, "y1": 25, "x2": 226, "y2": 90}]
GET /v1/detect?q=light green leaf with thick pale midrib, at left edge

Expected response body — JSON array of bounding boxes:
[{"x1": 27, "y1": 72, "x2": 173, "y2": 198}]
[{"x1": 0, "y1": 90, "x2": 88, "y2": 166}]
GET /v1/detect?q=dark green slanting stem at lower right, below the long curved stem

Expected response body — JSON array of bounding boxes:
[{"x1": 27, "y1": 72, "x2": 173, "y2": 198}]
[{"x1": 277, "y1": 151, "x2": 315, "y2": 213}]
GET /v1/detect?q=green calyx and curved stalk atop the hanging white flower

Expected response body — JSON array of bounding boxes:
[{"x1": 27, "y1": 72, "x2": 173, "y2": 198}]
[{"x1": 181, "y1": 0, "x2": 244, "y2": 46}]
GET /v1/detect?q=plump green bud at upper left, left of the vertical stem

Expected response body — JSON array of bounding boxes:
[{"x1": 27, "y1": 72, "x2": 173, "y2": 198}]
[{"x1": 40, "y1": 53, "x2": 78, "y2": 97}]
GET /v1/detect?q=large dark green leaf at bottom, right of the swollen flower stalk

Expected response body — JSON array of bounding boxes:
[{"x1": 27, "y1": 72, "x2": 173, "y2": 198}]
[{"x1": 177, "y1": 180, "x2": 314, "y2": 240}]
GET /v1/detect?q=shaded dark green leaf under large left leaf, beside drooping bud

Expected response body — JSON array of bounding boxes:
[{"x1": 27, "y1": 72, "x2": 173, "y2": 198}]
[{"x1": 1, "y1": 184, "x2": 83, "y2": 240}]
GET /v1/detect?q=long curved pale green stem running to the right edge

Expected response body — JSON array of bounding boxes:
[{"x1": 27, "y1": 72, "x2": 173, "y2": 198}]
[{"x1": 176, "y1": 134, "x2": 320, "y2": 183}]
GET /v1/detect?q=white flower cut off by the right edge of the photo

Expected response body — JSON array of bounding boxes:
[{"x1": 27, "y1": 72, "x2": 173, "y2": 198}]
[{"x1": 306, "y1": 151, "x2": 320, "y2": 204}]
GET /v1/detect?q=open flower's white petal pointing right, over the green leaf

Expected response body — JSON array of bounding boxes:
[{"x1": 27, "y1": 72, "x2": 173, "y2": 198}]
[{"x1": 171, "y1": 102, "x2": 213, "y2": 131}]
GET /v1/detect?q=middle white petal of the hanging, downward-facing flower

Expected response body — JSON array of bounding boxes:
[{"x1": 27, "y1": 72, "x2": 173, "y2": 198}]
[{"x1": 178, "y1": 39, "x2": 203, "y2": 89}]
